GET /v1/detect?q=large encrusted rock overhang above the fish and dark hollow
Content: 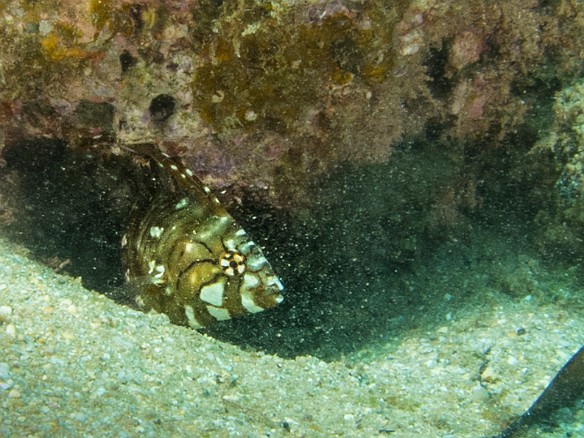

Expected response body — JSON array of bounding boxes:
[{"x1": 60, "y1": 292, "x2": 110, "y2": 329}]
[{"x1": 0, "y1": 0, "x2": 584, "y2": 209}]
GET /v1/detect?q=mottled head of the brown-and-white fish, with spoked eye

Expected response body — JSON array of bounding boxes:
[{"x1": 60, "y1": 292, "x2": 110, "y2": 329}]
[{"x1": 171, "y1": 214, "x2": 284, "y2": 327}]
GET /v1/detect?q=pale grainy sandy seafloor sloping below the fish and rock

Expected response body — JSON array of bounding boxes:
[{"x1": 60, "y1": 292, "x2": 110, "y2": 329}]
[{"x1": 0, "y1": 234, "x2": 584, "y2": 437}]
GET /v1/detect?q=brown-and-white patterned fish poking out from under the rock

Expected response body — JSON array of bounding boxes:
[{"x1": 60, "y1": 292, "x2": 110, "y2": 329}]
[{"x1": 121, "y1": 143, "x2": 284, "y2": 329}]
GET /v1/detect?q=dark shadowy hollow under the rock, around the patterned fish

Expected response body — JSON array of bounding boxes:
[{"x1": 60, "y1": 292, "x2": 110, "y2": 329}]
[{"x1": 2, "y1": 139, "x2": 560, "y2": 359}]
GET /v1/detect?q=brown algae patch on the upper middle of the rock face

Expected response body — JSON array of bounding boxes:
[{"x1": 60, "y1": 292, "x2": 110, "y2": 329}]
[{"x1": 193, "y1": 1, "x2": 399, "y2": 132}]
